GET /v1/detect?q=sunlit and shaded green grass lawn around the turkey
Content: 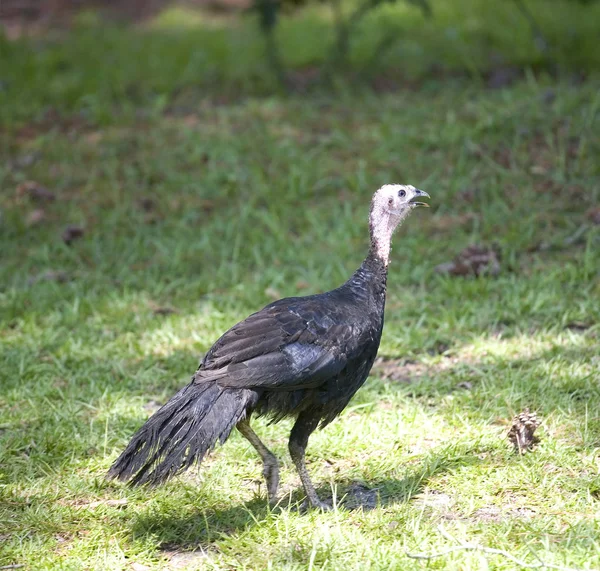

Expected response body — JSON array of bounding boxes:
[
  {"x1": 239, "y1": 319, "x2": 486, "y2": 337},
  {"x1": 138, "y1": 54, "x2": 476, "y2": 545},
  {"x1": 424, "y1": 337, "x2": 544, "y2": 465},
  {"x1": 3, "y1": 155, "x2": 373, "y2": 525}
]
[{"x1": 0, "y1": 3, "x2": 600, "y2": 571}]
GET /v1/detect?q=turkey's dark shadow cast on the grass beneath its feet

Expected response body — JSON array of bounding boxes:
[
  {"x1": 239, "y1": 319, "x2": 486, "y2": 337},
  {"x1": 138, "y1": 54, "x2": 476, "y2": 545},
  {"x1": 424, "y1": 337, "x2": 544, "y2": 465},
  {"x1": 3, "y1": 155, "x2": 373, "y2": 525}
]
[{"x1": 132, "y1": 447, "x2": 484, "y2": 551}]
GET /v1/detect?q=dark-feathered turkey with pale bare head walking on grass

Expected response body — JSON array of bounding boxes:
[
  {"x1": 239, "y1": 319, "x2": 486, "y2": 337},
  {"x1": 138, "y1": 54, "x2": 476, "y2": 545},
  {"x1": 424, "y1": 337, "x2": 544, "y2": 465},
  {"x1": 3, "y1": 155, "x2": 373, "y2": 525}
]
[{"x1": 108, "y1": 184, "x2": 429, "y2": 509}]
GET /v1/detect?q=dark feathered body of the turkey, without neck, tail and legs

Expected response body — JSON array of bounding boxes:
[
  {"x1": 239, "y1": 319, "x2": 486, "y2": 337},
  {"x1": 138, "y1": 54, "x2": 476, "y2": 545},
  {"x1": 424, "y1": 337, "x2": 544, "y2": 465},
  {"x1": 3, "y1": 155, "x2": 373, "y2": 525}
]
[{"x1": 221, "y1": 258, "x2": 386, "y2": 426}]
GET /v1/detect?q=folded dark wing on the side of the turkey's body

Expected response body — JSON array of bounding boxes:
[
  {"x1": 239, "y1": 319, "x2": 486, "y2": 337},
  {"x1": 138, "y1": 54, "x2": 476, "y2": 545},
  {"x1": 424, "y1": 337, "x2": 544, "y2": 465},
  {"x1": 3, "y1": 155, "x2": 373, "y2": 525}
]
[{"x1": 196, "y1": 298, "x2": 370, "y2": 390}]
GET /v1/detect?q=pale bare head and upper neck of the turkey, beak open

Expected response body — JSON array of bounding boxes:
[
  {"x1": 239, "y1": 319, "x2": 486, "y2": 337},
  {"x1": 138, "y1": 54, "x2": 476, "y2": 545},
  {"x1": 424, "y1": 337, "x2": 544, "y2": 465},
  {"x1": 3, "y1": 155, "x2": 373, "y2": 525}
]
[{"x1": 369, "y1": 184, "x2": 429, "y2": 265}]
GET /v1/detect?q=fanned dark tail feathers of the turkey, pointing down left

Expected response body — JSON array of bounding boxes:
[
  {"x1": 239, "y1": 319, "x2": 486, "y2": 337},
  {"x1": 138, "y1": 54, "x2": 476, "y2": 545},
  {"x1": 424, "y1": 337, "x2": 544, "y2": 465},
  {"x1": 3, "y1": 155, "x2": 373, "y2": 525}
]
[{"x1": 107, "y1": 382, "x2": 254, "y2": 485}]
